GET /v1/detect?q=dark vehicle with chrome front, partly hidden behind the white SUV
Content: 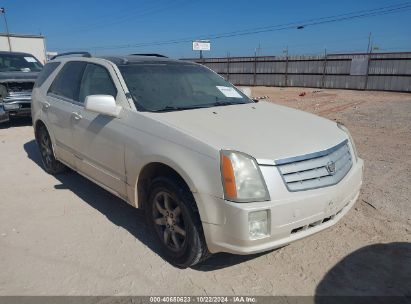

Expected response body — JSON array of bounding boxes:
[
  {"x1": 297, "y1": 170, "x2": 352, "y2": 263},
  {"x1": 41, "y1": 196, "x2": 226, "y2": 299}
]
[{"x1": 0, "y1": 52, "x2": 43, "y2": 122}]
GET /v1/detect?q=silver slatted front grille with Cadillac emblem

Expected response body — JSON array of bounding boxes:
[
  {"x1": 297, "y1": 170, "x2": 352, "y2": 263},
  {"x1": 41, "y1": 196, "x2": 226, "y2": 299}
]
[{"x1": 275, "y1": 140, "x2": 352, "y2": 191}]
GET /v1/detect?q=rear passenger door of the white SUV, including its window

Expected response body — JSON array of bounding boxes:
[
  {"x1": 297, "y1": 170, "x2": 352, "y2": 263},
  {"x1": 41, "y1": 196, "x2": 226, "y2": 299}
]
[{"x1": 43, "y1": 61, "x2": 87, "y2": 167}]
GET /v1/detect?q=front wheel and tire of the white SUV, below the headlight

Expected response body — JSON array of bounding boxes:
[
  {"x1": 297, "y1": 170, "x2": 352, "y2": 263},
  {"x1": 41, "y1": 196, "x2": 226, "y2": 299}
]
[{"x1": 146, "y1": 177, "x2": 210, "y2": 268}]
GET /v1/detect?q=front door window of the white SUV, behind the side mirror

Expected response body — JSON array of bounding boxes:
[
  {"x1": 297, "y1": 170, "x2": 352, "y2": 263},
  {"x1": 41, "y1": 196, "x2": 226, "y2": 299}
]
[{"x1": 79, "y1": 63, "x2": 117, "y2": 103}]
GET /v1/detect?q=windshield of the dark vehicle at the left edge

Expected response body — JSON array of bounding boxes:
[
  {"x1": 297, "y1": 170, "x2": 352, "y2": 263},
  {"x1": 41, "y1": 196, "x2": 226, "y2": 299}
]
[{"x1": 0, "y1": 54, "x2": 43, "y2": 72}]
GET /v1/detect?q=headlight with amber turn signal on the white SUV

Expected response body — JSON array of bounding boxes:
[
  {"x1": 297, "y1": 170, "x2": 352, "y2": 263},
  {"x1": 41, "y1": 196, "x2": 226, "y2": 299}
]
[{"x1": 221, "y1": 151, "x2": 270, "y2": 202}]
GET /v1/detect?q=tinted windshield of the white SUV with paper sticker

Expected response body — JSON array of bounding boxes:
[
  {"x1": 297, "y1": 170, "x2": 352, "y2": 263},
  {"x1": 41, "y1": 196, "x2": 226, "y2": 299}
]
[{"x1": 119, "y1": 63, "x2": 253, "y2": 112}]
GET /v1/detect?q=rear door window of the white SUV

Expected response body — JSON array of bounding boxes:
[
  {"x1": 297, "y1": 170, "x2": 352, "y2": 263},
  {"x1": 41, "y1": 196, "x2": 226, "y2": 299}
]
[{"x1": 49, "y1": 61, "x2": 87, "y2": 101}]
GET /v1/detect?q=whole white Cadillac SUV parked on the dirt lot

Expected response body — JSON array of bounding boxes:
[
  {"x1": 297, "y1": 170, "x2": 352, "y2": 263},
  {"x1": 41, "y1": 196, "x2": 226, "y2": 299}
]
[{"x1": 32, "y1": 53, "x2": 363, "y2": 268}]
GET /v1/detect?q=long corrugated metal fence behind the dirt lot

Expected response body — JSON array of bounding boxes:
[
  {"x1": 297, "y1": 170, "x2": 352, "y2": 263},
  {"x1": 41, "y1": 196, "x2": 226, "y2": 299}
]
[{"x1": 186, "y1": 52, "x2": 411, "y2": 92}]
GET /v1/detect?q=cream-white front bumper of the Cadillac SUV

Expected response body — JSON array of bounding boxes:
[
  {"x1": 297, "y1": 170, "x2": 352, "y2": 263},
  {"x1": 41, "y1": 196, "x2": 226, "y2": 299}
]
[{"x1": 201, "y1": 159, "x2": 363, "y2": 254}]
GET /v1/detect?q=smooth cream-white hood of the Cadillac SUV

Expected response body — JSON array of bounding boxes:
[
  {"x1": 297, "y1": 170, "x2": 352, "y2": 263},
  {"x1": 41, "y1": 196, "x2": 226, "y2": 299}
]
[{"x1": 145, "y1": 102, "x2": 347, "y2": 163}]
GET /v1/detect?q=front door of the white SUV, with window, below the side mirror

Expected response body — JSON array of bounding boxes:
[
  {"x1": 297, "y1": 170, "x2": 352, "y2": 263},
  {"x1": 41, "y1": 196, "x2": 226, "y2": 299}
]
[{"x1": 73, "y1": 63, "x2": 126, "y2": 197}]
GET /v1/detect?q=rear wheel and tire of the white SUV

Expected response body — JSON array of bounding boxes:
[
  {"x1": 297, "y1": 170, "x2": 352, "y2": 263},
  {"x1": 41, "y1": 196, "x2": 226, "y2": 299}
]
[{"x1": 36, "y1": 126, "x2": 67, "y2": 175}]
